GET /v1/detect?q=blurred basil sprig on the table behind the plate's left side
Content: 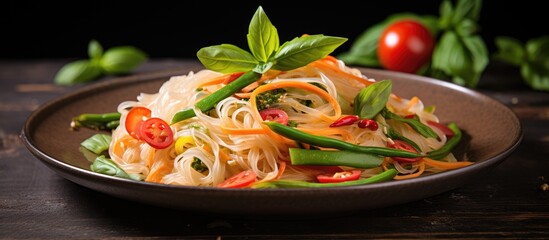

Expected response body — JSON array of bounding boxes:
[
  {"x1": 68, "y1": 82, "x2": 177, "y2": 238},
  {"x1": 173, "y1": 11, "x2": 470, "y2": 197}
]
[{"x1": 54, "y1": 40, "x2": 148, "y2": 85}]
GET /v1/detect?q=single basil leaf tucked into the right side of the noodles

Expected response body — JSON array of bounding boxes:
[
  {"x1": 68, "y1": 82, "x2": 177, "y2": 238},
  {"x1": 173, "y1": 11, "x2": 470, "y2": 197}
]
[{"x1": 354, "y1": 80, "x2": 392, "y2": 119}]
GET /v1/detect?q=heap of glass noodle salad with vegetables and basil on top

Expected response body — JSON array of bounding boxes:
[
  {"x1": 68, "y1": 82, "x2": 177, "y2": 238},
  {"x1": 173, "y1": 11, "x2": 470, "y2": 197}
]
[{"x1": 72, "y1": 7, "x2": 472, "y2": 188}]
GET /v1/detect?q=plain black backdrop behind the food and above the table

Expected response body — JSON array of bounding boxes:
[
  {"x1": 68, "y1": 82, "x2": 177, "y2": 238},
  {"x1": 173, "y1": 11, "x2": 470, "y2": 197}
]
[{"x1": 0, "y1": 0, "x2": 549, "y2": 59}]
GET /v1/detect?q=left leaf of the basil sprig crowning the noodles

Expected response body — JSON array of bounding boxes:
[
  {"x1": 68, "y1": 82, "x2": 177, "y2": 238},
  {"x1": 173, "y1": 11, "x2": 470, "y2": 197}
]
[{"x1": 196, "y1": 44, "x2": 258, "y2": 73}]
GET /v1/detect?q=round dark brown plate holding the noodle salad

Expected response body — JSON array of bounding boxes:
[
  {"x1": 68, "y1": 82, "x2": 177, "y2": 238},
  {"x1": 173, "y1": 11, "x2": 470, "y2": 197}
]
[{"x1": 21, "y1": 65, "x2": 522, "y2": 216}]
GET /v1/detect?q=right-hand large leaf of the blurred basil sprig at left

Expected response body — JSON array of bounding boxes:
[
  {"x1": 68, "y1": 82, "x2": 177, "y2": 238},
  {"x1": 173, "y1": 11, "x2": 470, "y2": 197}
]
[{"x1": 100, "y1": 46, "x2": 148, "y2": 74}]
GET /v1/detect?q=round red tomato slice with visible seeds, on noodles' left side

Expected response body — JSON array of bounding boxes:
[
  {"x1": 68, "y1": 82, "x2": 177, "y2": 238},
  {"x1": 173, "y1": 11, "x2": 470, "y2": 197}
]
[{"x1": 138, "y1": 118, "x2": 173, "y2": 149}]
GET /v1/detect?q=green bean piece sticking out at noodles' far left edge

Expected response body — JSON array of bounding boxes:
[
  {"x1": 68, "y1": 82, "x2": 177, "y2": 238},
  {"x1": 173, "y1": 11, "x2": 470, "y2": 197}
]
[{"x1": 71, "y1": 112, "x2": 122, "y2": 130}]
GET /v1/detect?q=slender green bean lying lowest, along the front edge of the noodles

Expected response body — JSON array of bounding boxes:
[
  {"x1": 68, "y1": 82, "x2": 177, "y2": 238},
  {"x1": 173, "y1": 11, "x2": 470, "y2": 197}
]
[{"x1": 252, "y1": 169, "x2": 398, "y2": 188}]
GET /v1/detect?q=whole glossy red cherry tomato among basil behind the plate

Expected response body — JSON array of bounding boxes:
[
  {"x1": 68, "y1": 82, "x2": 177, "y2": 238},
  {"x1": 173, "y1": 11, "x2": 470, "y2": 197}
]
[{"x1": 377, "y1": 19, "x2": 435, "y2": 73}]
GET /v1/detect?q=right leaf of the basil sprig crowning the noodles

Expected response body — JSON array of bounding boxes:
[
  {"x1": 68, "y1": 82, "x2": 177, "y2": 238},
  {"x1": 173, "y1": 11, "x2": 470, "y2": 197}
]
[{"x1": 272, "y1": 35, "x2": 347, "y2": 71}]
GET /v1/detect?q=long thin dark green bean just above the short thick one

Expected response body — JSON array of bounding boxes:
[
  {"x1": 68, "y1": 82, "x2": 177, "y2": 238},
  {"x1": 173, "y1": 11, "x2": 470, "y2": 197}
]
[{"x1": 263, "y1": 121, "x2": 423, "y2": 158}]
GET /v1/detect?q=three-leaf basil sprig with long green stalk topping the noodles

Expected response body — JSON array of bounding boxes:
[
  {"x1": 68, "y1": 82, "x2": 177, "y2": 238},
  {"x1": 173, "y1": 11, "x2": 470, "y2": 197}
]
[{"x1": 171, "y1": 6, "x2": 347, "y2": 124}]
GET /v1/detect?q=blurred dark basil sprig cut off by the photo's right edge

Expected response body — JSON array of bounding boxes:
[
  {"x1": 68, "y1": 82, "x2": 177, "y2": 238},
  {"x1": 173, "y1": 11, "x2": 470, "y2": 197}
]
[{"x1": 493, "y1": 35, "x2": 549, "y2": 91}]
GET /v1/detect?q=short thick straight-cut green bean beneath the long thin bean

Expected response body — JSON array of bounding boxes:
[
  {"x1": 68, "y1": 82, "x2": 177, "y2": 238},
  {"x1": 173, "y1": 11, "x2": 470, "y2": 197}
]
[{"x1": 290, "y1": 148, "x2": 383, "y2": 168}]
